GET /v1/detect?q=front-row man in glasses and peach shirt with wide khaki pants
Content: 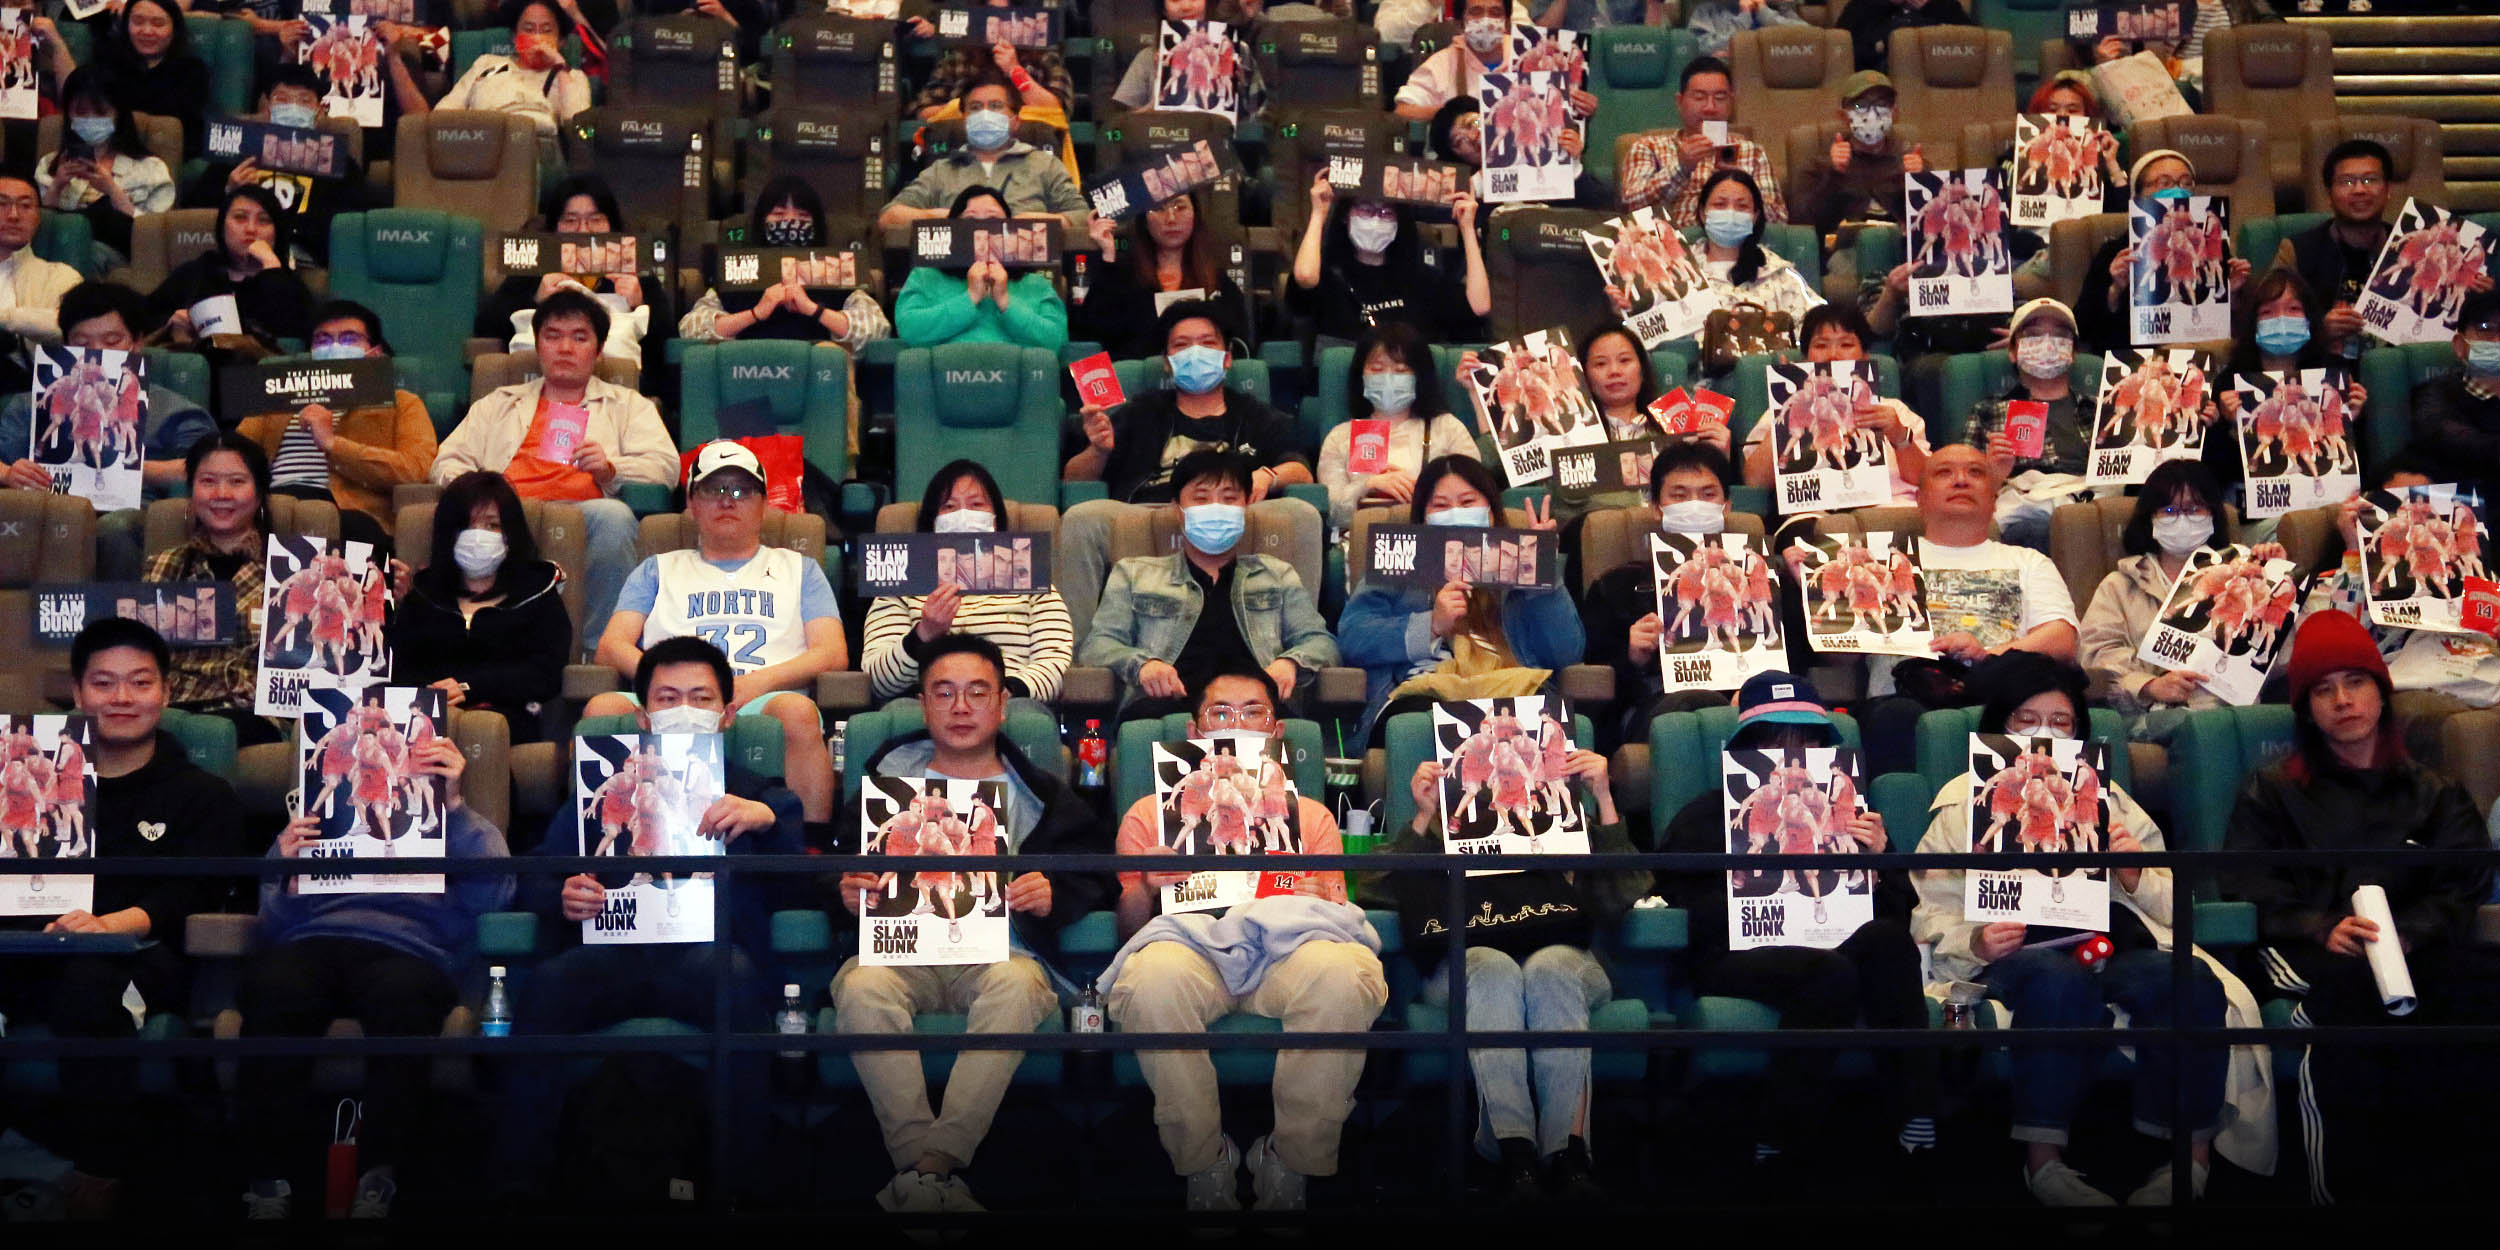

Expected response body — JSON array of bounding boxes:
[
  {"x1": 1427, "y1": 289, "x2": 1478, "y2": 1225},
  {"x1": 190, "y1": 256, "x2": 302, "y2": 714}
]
[{"x1": 1105, "y1": 665, "x2": 1388, "y2": 1210}]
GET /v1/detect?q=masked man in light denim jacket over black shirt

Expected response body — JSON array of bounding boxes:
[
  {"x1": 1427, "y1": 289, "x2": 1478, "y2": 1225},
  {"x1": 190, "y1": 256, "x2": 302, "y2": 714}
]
[{"x1": 1078, "y1": 450, "x2": 1338, "y2": 720}]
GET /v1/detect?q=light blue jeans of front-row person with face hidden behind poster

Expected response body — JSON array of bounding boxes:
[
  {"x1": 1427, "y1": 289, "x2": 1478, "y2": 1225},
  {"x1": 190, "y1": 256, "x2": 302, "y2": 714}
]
[{"x1": 1423, "y1": 945, "x2": 1615, "y2": 1158}]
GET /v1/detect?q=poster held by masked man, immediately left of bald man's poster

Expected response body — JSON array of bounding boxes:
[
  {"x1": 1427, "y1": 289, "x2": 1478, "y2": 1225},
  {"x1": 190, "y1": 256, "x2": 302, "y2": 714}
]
[{"x1": 1650, "y1": 533, "x2": 1788, "y2": 690}]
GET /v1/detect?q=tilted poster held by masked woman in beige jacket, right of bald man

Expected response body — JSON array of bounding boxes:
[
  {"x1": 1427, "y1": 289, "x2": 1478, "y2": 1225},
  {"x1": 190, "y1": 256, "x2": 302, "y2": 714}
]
[{"x1": 2135, "y1": 543, "x2": 2300, "y2": 708}]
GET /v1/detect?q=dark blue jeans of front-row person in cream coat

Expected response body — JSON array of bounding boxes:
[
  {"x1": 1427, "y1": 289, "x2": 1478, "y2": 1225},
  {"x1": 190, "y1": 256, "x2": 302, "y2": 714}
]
[{"x1": 1988, "y1": 948, "x2": 2230, "y2": 1145}]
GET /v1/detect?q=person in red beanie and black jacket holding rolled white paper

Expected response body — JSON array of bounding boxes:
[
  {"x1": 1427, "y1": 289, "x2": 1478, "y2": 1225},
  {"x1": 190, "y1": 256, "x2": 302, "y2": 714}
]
[{"x1": 2225, "y1": 610, "x2": 2500, "y2": 1203}]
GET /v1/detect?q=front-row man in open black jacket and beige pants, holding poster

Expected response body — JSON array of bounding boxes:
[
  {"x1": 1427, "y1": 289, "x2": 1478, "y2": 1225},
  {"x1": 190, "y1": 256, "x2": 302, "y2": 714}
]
[{"x1": 833, "y1": 633, "x2": 1113, "y2": 1213}]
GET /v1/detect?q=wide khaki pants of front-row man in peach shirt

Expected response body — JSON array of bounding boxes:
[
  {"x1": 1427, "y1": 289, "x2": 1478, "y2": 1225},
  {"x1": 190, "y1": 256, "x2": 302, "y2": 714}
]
[{"x1": 1108, "y1": 943, "x2": 1390, "y2": 1175}]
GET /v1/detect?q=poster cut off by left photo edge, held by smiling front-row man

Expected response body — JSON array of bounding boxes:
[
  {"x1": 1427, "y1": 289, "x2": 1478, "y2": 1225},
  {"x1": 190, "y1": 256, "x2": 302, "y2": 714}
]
[{"x1": 0, "y1": 715, "x2": 95, "y2": 915}]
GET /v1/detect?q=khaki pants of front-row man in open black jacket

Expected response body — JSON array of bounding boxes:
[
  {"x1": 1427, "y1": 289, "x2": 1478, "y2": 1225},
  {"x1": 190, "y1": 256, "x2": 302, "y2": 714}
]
[{"x1": 833, "y1": 955, "x2": 1060, "y2": 1168}]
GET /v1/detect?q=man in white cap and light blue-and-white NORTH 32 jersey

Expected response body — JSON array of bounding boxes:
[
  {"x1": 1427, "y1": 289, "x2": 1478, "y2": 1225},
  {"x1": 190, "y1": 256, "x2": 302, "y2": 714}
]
[{"x1": 583, "y1": 440, "x2": 850, "y2": 825}]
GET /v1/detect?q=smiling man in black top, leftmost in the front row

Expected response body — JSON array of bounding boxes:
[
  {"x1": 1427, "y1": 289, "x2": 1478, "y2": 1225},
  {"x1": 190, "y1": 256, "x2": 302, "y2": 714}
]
[{"x1": 0, "y1": 618, "x2": 245, "y2": 1215}]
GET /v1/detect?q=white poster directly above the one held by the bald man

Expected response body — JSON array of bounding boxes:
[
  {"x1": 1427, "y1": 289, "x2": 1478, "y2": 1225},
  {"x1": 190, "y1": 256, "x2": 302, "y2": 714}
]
[{"x1": 1763, "y1": 360, "x2": 1893, "y2": 515}]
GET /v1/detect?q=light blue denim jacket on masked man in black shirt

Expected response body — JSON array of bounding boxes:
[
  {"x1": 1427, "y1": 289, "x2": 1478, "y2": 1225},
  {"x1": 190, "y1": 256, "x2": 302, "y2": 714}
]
[{"x1": 1078, "y1": 553, "x2": 1338, "y2": 703}]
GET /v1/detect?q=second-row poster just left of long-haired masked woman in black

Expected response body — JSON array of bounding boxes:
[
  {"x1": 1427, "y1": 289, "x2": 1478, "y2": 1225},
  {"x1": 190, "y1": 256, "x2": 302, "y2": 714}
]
[{"x1": 255, "y1": 535, "x2": 390, "y2": 715}]
